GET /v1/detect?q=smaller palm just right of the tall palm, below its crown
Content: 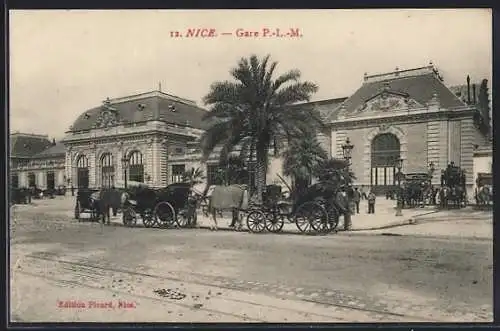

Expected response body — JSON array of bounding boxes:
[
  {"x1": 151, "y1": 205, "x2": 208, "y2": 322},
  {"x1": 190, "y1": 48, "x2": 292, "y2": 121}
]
[{"x1": 283, "y1": 134, "x2": 328, "y2": 200}]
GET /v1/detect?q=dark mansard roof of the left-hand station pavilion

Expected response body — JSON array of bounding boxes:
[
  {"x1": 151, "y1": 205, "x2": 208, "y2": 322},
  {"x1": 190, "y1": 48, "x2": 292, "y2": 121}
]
[{"x1": 70, "y1": 91, "x2": 207, "y2": 131}]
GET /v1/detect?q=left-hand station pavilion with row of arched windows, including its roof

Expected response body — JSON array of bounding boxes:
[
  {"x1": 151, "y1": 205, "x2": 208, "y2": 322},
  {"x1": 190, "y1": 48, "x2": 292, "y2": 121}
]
[{"x1": 64, "y1": 91, "x2": 205, "y2": 187}]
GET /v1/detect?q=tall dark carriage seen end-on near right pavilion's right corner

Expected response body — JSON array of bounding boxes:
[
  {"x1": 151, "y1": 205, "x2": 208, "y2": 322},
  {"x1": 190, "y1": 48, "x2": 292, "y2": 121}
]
[{"x1": 439, "y1": 162, "x2": 467, "y2": 208}]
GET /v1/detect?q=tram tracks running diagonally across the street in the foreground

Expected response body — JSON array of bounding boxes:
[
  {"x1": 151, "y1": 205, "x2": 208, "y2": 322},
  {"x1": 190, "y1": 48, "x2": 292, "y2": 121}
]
[{"x1": 15, "y1": 254, "x2": 442, "y2": 322}]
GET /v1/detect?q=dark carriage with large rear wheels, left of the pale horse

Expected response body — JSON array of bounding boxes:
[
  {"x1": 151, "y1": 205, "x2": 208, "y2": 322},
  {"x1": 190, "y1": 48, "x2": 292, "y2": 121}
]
[{"x1": 122, "y1": 183, "x2": 191, "y2": 228}]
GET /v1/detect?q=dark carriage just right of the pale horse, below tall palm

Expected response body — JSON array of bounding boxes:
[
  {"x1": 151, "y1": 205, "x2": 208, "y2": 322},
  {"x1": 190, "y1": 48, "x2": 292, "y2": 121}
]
[{"x1": 247, "y1": 183, "x2": 340, "y2": 233}]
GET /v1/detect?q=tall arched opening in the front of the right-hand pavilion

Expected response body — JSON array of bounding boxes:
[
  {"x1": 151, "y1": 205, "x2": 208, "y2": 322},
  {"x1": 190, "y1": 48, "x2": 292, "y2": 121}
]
[{"x1": 370, "y1": 133, "x2": 401, "y2": 194}]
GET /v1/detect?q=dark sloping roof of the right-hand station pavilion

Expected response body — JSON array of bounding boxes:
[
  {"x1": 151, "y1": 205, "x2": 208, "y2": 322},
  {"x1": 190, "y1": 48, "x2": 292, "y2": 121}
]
[{"x1": 329, "y1": 72, "x2": 465, "y2": 121}]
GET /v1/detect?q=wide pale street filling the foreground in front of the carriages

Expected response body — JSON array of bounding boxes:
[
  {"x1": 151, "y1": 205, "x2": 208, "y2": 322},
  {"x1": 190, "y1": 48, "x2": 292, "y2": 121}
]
[{"x1": 10, "y1": 198, "x2": 493, "y2": 322}]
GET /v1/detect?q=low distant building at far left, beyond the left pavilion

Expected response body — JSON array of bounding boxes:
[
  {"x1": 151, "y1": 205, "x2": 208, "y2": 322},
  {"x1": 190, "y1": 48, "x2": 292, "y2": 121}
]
[{"x1": 10, "y1": 132, "x2": 65, "y2": 189}]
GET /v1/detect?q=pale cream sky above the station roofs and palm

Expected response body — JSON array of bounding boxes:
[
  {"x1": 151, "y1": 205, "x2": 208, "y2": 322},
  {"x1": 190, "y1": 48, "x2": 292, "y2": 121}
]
[{"x1": 9, "y1": 9, "x2": 492, "y2": 138}]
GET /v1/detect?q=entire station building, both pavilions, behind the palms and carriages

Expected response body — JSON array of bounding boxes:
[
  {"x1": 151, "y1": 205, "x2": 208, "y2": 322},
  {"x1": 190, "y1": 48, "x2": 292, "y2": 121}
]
[{"x1": 11, "y1": 64, "x2": 491, "y2": 201}]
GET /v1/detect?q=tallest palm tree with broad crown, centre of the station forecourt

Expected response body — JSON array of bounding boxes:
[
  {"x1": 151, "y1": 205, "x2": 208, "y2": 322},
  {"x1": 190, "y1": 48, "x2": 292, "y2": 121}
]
[{"x1": 201, "y1": 55, "x2": 321, "y2": 201}]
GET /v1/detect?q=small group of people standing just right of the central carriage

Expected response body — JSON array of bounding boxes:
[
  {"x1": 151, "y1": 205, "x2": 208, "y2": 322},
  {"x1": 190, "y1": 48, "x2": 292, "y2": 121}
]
[{"x1": 336, "y1": 186, "x2": 376, "y2": 231}]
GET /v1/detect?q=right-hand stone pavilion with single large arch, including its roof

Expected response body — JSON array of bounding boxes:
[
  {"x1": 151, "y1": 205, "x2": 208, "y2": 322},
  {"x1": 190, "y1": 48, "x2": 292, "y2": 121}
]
[{"x1": 316, "y1": 65, "x2": 485, "y2": 200}]
